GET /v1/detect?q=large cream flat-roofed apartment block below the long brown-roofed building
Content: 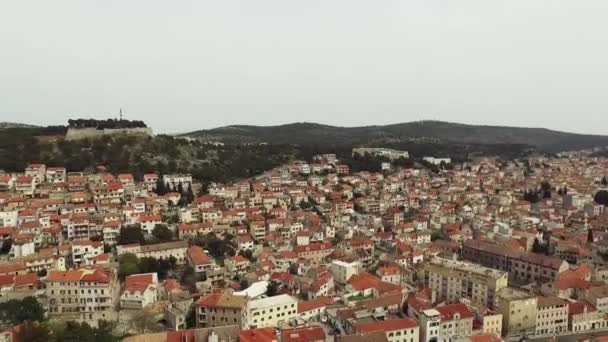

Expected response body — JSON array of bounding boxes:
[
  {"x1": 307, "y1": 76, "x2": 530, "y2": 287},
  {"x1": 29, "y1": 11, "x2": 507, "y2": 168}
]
[{"x1": 423, "y1": 258, "x2": 508, "y2": 309}]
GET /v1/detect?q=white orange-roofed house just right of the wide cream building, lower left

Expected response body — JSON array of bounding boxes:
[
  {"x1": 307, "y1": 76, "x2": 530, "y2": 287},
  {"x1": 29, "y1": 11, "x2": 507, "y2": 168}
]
[{"x1": 120, "y1": 273, "x2": 159, "y2": 309}]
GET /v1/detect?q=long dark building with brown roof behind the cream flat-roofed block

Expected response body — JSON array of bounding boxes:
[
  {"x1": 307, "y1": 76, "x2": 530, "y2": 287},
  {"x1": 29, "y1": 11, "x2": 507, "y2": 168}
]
[{"x1": 462, "y1": 240, "x2": 569, "y2": 282}]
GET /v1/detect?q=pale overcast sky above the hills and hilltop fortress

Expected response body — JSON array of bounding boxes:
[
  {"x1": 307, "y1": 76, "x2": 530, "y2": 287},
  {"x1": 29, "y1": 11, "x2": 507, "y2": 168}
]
[{"x1": 0, "y1": 0, "x2": 608, "y2": 135}]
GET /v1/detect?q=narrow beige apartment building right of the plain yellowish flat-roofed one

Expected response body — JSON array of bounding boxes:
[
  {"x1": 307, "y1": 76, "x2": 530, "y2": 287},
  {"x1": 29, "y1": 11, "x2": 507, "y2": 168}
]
[{"x1": 535, "y1": 297, "x2": 568, "y2": 335}]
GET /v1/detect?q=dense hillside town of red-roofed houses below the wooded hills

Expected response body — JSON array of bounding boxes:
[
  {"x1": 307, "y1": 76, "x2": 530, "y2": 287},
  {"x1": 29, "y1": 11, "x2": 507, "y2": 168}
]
[{"x1": 0, "y1": 148, "x2": 608, "y2": 342}]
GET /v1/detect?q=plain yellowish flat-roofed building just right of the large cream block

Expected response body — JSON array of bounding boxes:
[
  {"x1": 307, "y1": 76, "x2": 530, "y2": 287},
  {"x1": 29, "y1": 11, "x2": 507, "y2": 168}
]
[{"x1": 497, "y1": 287, "x2": 537, "y2": 334}]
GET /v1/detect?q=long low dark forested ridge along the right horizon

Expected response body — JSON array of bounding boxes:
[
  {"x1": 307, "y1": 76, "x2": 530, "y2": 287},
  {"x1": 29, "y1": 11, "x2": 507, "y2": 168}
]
[{"x1": 182, "y1": 121, "x2": 608, "y2": 152}]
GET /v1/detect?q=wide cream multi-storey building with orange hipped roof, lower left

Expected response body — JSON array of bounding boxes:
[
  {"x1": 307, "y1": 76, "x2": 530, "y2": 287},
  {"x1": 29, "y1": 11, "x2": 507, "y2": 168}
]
[{"x1": 45, "y1": 266, "x2": 118, "y2": 324}]
